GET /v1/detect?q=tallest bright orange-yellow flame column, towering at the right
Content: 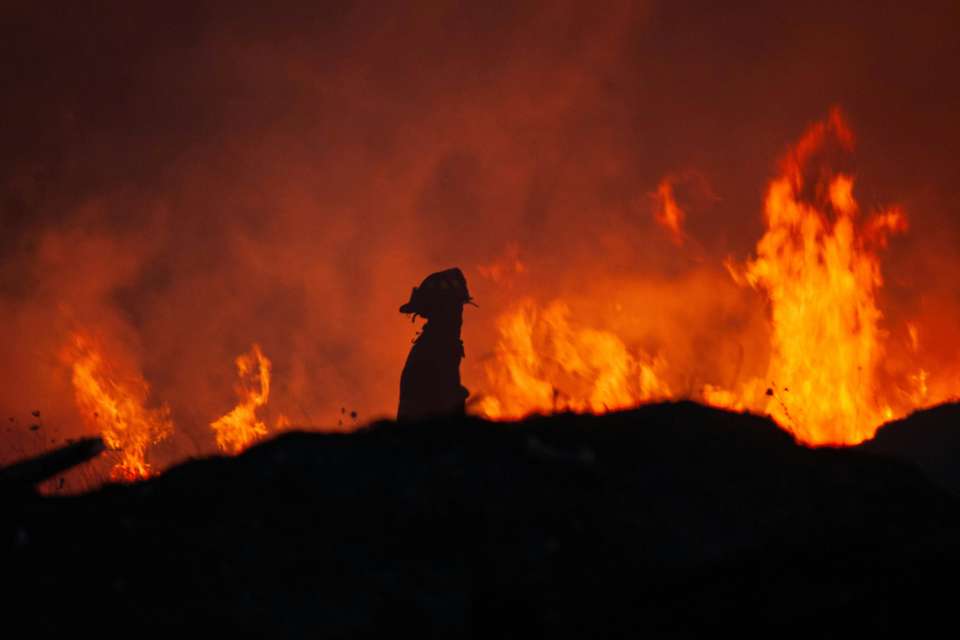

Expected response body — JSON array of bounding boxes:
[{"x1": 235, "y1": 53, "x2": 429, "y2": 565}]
[{"x1": 746, "y1": 111, "x2": 906, "y2": 444}]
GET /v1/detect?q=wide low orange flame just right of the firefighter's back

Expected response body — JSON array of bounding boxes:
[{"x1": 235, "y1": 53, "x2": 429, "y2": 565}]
[{"x1": 478, "y1": 300, "x2": 670, "y2": 419}]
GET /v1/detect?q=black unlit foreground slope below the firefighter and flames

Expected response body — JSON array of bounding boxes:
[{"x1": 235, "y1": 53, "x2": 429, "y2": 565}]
[{"x1": 0, "y1": 403, "x2": 960, "y2": 638}]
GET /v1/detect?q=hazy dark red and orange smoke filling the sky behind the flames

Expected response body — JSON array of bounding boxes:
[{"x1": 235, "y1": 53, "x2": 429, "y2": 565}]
[{"x1": 0, "y1": 1, "x2": 960, "y2": 463}]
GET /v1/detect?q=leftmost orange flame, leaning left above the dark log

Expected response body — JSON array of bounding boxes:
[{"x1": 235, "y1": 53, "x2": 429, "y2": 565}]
[{"x1": 67, "y1": 333, "x2": 173, "y2": 482}]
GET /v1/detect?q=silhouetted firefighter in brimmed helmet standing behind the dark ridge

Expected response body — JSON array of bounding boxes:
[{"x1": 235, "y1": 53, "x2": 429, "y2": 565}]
[{"x1": 397, "y1": 268, "x2": 473, "y2": 420}]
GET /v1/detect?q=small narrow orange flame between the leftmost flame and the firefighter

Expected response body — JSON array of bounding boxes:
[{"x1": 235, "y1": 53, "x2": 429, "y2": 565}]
[{"x1": 210, "y1": 344, "x2": 270, "y2": 454}]
